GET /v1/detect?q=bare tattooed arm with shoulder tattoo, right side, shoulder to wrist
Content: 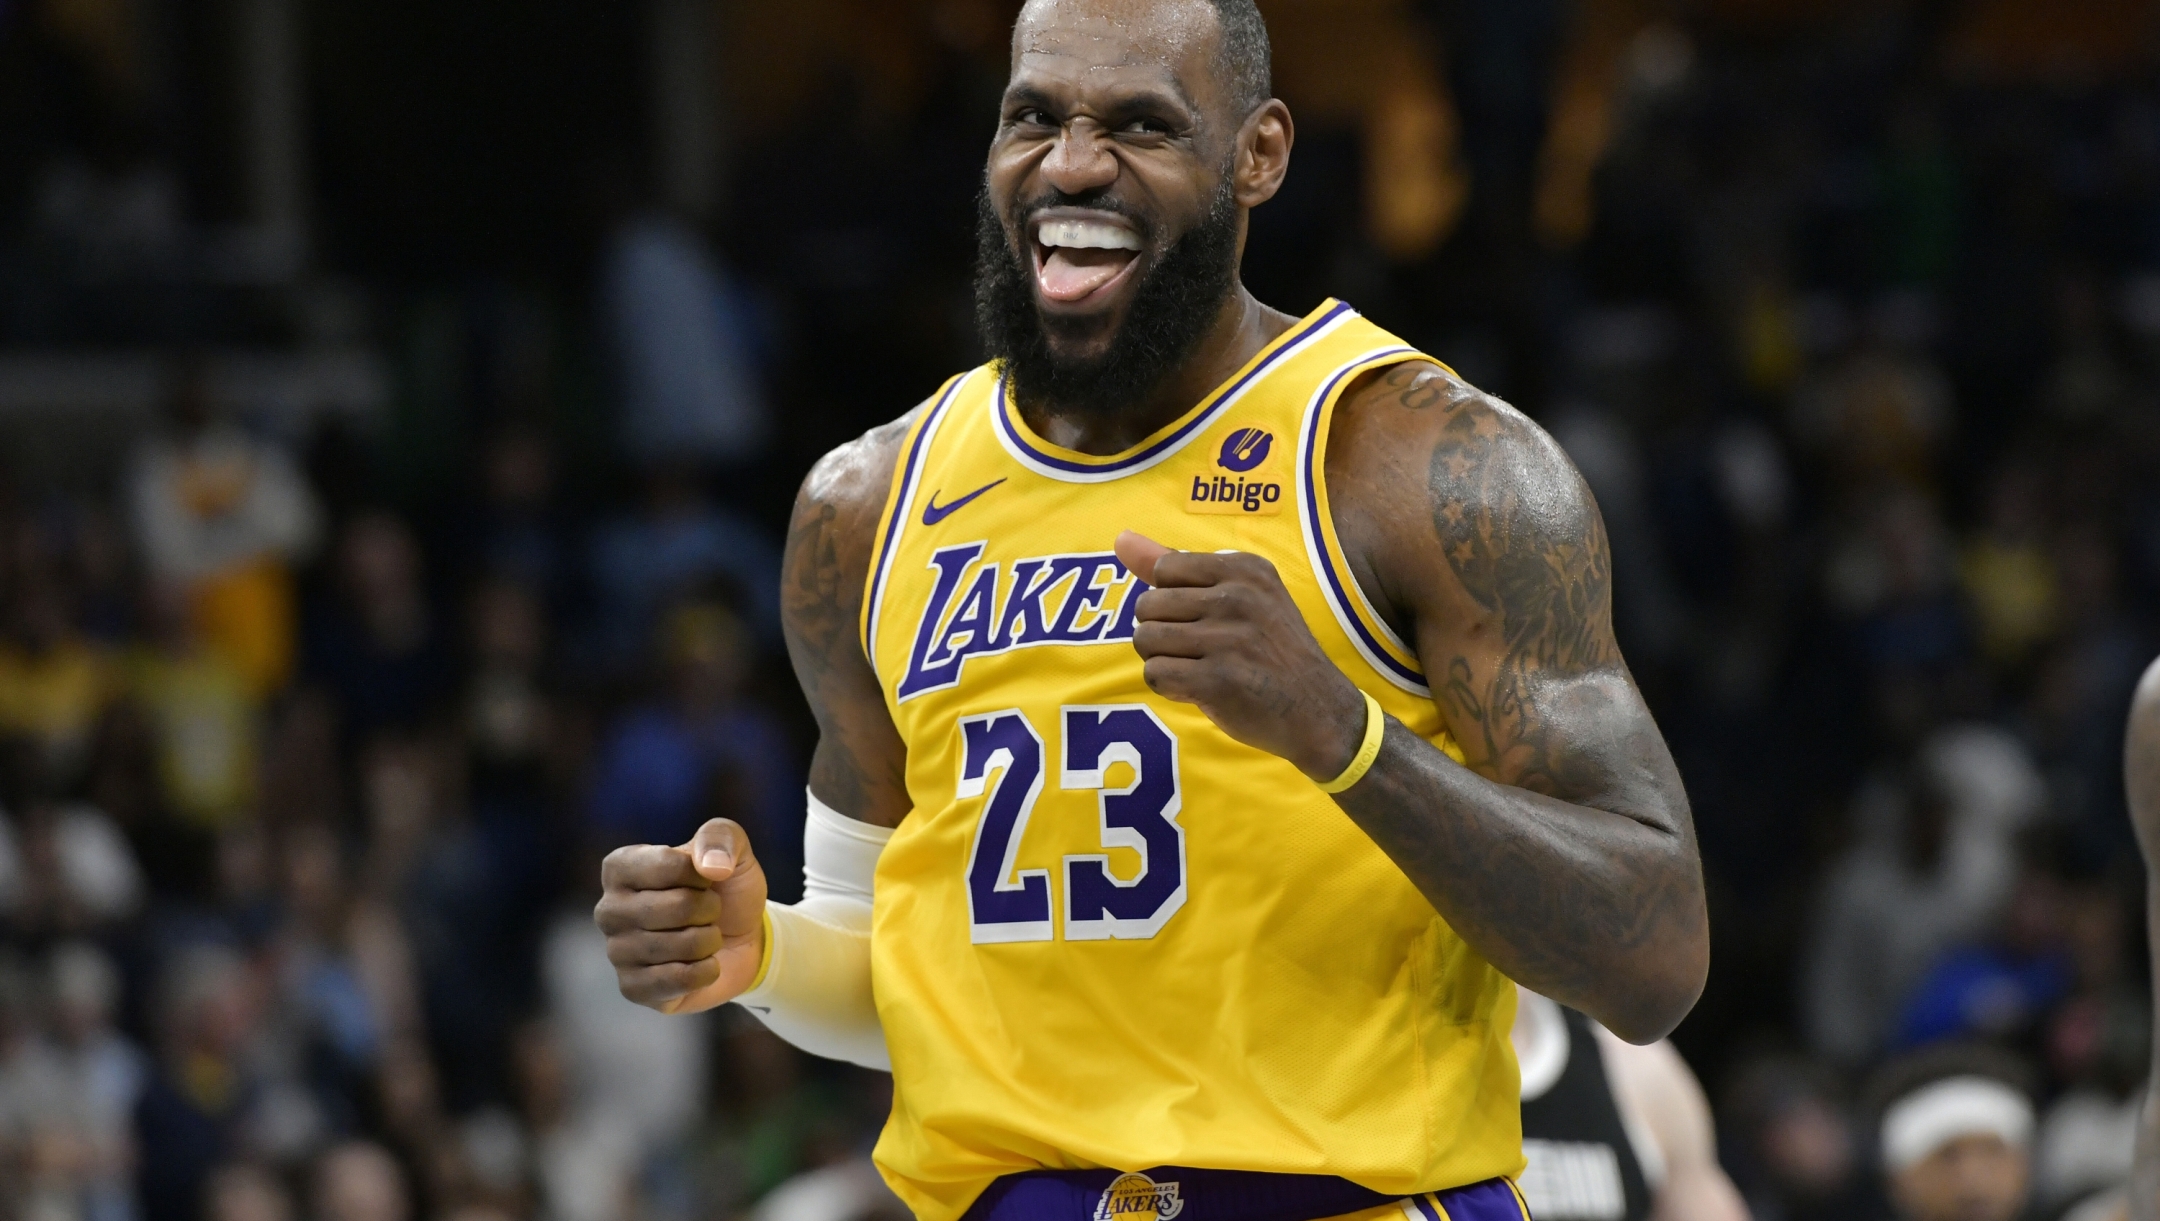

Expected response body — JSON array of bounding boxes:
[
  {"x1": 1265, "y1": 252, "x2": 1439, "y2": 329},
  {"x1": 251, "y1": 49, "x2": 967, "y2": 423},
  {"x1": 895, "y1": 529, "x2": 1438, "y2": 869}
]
[{"x1": 1326, "y1": 363, "x2": 1709, "y2": 1042}]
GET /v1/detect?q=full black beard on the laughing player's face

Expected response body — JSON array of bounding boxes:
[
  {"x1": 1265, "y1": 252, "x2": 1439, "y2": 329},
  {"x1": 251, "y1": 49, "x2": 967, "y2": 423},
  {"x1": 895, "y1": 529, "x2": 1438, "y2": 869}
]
[{"x1": 974, "y1": 175, "x2": 1238, "y2": 417}]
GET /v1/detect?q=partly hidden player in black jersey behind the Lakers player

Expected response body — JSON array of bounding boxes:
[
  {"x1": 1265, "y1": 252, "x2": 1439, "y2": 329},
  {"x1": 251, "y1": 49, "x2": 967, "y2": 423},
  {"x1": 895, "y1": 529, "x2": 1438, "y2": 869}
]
[{"x1": 1512, "y1": 990, "x2": 1747, "y2": 1221}]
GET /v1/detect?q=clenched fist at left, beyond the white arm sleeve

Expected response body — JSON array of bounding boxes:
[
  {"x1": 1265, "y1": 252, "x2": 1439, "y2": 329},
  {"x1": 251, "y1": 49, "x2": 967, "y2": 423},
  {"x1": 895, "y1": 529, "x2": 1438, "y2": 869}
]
[{"x1": 592, "y1": 819, "x2": 765, "y2": 1014}]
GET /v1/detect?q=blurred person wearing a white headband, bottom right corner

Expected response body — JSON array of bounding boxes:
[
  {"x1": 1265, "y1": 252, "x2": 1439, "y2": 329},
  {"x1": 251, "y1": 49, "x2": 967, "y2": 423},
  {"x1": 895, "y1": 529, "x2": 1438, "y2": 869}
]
[{"x1": 1877, "y1": 1048, "x2": 2033, "y2": 1221}]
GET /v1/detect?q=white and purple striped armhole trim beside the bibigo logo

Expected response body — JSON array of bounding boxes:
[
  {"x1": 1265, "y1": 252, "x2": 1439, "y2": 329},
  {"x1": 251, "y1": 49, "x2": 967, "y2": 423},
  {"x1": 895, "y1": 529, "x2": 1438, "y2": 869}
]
[{"x1": 1298, "y1": 344, "x2": 1445, "y2": 700}]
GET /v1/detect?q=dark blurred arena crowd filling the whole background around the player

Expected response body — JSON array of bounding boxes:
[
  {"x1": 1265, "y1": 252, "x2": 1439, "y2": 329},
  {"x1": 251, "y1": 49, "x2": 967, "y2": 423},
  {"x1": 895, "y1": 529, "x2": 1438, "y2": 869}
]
[{"x1": 0, "y1": 0, "x2": 2160, "y2": 1221}]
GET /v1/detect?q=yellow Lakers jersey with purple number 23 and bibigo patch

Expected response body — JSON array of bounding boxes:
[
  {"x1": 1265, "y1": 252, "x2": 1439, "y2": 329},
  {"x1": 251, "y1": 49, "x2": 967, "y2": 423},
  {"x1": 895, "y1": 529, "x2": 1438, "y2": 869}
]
[{"x1": 862, "y1": 300, "x2": 1523, "y2": 1221}]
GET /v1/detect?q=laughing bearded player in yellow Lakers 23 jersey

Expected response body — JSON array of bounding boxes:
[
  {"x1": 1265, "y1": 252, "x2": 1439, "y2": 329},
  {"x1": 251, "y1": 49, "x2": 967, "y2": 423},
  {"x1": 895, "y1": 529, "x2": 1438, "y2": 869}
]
[{"x1": 596, "y1": 0, "x2": 1709, "y2": 1221}]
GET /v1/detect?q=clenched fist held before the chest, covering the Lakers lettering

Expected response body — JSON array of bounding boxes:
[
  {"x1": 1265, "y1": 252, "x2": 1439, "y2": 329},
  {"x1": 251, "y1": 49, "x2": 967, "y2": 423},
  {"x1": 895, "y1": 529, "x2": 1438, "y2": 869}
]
[{"x1": 1117, "y1": 529, "x2": 1365, "y2": 780}]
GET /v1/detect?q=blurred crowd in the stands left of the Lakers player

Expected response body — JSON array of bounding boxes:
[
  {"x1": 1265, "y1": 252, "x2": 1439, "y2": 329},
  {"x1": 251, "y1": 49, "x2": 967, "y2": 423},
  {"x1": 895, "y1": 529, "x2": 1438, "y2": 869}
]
[{"x1": 0, "y1": 345, "x2": 902, "y2": 1221}]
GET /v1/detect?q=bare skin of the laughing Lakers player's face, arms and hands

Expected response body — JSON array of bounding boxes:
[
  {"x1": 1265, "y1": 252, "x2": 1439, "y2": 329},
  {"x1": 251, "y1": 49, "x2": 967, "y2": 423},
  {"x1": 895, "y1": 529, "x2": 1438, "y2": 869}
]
[{"x1": 596, "y1": 0, "x2": 1709, "y2": 1042}]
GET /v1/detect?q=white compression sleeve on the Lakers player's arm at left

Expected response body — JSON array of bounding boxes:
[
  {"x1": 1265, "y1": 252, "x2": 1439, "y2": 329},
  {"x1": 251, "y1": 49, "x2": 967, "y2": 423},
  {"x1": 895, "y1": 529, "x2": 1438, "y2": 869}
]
[{"x1": 734, "y1": 793, "x2": 892, "y2": 1072}]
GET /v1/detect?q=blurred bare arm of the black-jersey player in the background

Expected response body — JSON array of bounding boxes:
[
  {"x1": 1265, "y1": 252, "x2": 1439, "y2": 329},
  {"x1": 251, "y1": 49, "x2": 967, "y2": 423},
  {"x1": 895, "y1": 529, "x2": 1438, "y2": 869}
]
[{"x1": 1598, "y1": 1029, "x2": 1747, "y2": 1221}]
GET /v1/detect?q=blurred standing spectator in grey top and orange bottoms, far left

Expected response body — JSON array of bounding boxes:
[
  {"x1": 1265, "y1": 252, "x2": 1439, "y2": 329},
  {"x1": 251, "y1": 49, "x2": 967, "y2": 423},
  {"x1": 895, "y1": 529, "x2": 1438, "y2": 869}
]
[{"x1": 127, "y1": 359, "x2": 318, "y2": 696}]
